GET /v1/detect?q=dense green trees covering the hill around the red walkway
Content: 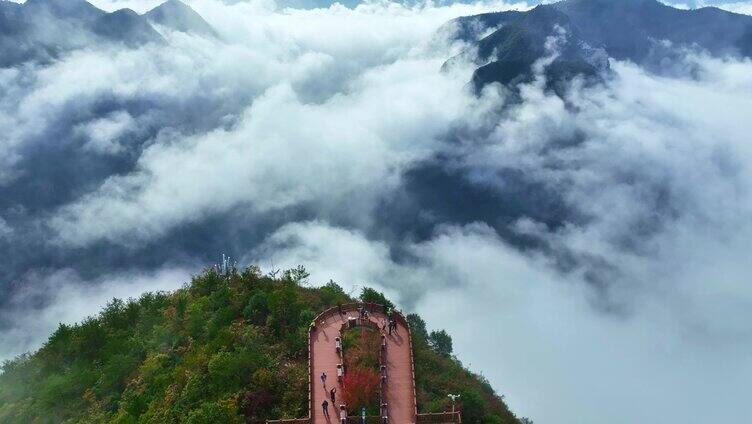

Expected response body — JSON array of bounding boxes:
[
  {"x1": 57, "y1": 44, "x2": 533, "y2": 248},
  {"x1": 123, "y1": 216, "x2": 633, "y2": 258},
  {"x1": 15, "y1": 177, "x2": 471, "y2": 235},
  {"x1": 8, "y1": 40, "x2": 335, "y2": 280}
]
[{"x1": 0, "y1": 267, "x2": 517, "y2": 424}]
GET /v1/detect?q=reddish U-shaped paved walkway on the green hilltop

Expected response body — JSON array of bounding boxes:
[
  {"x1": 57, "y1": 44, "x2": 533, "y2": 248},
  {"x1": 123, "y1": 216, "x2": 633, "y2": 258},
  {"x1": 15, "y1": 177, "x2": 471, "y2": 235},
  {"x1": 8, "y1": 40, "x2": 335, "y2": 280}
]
[{"x1": 311, "y1": 310, "x2": 415, "y2": 424}]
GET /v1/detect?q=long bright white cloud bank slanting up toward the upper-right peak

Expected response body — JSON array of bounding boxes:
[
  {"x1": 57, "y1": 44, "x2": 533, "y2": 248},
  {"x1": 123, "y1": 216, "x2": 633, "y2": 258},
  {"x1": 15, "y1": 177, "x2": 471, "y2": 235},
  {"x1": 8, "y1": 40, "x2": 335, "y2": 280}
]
[{"x1": 53, "y1": 60, "x2": 470, "y2": 244}]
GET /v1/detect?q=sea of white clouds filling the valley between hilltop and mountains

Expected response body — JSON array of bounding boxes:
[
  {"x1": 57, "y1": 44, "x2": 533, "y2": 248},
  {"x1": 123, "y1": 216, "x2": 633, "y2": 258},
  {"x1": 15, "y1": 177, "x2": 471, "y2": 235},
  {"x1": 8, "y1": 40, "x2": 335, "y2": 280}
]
[{"x1": 0, "y1": 0, "x2": 752, "y2": 424}]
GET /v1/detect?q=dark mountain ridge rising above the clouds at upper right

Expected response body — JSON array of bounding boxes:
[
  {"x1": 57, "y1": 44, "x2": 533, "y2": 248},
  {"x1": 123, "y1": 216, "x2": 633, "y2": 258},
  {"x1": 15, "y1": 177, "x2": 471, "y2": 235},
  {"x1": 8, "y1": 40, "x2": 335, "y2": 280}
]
[{"x1": 443, "y1": 0, "x2": 752, "y2": 93}]
